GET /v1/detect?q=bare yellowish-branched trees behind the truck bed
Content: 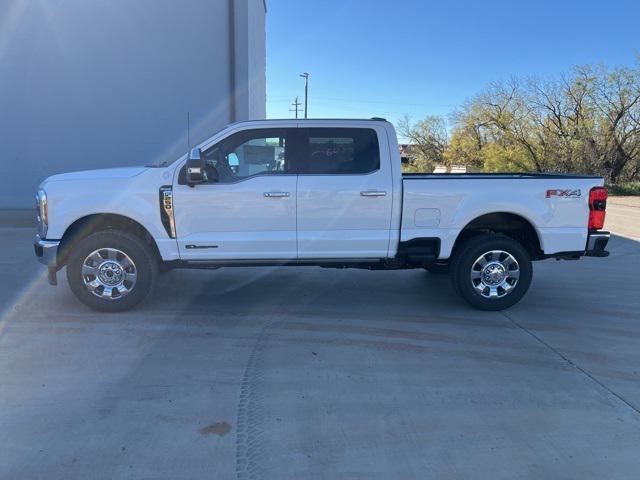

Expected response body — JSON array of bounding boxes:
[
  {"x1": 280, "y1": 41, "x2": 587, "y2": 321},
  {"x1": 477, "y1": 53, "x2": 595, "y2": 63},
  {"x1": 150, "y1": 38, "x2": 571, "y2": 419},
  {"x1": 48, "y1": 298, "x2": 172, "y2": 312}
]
[{"x1": 443, "y1": 62, "x2": 640, "y2": 183}]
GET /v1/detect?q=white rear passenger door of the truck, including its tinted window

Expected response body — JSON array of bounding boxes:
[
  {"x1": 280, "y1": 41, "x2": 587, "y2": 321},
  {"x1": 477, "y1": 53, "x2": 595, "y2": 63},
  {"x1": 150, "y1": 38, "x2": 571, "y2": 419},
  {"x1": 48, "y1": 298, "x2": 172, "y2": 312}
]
[{"x1": 297, "y1": 127, "x2": 393, "y2": 258}]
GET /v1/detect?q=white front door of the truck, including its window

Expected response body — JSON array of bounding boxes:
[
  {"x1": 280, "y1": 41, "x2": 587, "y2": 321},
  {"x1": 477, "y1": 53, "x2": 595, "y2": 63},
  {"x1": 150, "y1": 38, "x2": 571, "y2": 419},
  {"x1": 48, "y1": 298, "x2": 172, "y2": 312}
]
[{"x1": 174, "y1": 128, "x2": 297, "y2": 260}]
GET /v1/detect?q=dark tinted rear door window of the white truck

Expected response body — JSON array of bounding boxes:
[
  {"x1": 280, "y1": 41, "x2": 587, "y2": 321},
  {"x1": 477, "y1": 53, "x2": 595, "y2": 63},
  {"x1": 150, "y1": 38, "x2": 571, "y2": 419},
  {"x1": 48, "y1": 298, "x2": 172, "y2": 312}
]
[{"x1": 296, "y1": 128, "x2": 380, "y2": 175}]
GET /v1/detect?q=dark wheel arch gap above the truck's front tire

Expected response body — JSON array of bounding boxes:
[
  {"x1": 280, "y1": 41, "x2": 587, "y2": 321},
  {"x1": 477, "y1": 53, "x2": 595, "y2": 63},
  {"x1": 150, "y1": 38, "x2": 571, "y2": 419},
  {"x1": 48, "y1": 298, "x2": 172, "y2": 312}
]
[{"x1": 57, "y1": 213, "x2": 162, "y2": 268}]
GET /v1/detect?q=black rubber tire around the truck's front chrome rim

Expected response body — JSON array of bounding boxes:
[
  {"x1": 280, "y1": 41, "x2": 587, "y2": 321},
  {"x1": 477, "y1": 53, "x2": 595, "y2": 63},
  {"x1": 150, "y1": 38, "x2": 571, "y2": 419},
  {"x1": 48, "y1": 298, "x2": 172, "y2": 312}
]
[{"x1": 67, "y1": 230, "x2": 158, "y2": 312}]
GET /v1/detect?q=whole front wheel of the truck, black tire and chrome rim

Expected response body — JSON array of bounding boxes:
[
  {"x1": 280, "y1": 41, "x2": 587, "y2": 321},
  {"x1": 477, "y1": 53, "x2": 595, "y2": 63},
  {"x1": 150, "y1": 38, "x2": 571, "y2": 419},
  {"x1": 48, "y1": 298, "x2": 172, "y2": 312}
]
[{"x1": 67, "y1": 230, "x2": 158, "y2": 312}]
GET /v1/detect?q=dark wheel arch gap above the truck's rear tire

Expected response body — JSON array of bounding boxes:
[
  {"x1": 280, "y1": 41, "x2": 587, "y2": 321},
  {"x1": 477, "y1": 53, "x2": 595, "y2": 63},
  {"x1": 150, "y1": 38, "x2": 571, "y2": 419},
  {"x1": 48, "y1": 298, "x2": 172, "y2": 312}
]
[{"x1": 451, "y1": 212, "x2": 544, "y2": 260}]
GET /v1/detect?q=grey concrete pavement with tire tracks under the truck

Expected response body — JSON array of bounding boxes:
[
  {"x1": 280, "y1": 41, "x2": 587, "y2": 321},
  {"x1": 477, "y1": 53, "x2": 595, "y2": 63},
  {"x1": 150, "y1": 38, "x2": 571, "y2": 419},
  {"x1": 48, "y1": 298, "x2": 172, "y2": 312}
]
[{"x1": 0, "y1": 205, "x2": 640, "y2": 479}]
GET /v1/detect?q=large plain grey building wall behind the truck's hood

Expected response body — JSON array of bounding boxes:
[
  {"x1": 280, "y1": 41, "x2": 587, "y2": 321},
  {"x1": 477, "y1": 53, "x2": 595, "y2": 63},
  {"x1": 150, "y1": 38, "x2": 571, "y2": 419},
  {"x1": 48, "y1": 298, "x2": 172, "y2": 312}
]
[{"x1": 0, "y1": 0, "x2": 266, "y2": 208}]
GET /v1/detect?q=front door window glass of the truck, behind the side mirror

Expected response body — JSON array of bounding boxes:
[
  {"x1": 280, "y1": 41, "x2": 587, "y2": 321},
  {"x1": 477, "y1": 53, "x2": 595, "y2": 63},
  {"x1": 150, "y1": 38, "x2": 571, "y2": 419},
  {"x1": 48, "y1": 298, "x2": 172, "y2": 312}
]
[{"x1": 203, "y1": 129, "x2": 291, "y2": 183}]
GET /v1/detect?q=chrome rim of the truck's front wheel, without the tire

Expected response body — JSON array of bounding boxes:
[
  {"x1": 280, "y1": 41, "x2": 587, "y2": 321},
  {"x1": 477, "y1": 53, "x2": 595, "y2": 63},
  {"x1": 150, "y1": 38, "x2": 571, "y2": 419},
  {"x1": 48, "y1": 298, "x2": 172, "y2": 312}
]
[{"x1": 82, "y1": 248, "x2": 138, "y2": 300}]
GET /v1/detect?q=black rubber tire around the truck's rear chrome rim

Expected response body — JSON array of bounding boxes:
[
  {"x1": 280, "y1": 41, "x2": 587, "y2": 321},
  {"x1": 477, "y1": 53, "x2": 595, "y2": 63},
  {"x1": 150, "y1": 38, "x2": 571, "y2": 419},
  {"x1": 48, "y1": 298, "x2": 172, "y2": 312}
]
[{"x1": 451, "y1": 235, "x2": 533, "y2": 311}]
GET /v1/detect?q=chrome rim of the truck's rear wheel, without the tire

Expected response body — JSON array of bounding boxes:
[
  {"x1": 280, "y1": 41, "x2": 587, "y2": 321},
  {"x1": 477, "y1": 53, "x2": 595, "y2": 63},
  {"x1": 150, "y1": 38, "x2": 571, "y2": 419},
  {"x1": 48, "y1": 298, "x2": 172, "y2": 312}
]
[{"x1": 470, "y1": 250, "x2": 520, "y2": 299}]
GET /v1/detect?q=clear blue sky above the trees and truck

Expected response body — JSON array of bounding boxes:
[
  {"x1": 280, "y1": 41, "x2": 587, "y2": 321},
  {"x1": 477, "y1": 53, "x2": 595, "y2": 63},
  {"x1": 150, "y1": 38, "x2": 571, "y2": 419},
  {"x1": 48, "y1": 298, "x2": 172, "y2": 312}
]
[{"x1": 267, "y1": 0, "x2": 640, "y2": 127}]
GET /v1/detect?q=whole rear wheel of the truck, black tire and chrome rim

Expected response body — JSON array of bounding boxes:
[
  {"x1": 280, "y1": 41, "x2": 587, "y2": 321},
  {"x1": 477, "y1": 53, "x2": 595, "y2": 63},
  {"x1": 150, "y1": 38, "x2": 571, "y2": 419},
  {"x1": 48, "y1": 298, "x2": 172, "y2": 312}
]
[{"x1": 451, "y1": 235, "x2": 533, "y2": 311}]
